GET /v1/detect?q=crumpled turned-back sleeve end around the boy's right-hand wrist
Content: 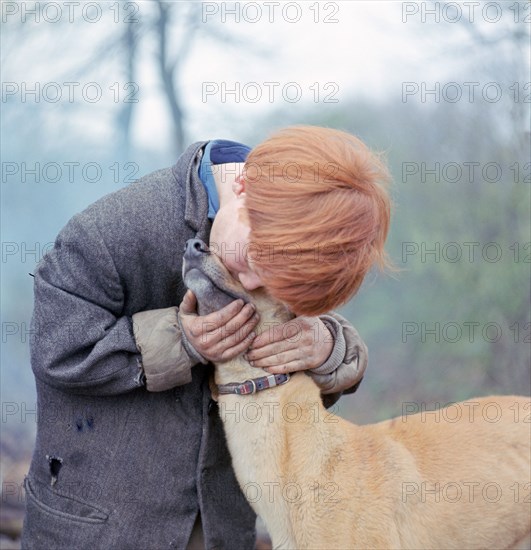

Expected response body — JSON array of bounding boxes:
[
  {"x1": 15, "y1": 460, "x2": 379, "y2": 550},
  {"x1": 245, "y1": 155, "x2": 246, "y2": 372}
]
[{"x1": 306, "y1": 312, "x2": 369, "y2": 407}]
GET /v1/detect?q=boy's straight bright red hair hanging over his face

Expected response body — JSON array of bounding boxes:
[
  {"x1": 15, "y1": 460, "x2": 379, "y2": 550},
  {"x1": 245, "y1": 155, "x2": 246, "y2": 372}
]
[{"x1": 244, "y1": 126, "x2": 390, "y2": 315}]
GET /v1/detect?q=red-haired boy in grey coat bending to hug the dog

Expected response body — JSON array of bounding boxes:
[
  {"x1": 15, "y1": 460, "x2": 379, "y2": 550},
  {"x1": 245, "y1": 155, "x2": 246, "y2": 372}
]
[{"x1": 22, "y1": 127, "x2": 389, "y2": 549}]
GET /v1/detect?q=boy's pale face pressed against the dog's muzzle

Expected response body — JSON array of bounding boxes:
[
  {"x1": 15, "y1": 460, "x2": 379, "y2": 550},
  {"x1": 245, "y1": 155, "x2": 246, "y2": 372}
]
[{"x1": 210, "y1": 193, "x2": 263, "y2": 290}]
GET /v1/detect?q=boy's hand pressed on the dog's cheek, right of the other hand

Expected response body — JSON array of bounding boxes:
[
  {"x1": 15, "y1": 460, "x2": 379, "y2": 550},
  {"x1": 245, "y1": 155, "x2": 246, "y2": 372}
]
[{"x1": 245, "y1": 316, "x2": 334, "y2": 374}]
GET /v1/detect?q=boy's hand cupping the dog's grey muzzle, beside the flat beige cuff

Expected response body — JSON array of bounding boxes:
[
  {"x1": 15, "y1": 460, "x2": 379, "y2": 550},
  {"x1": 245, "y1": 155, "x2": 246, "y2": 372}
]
[{"x1": 179, "y1": 290, "x2": 259, "y2": 361}]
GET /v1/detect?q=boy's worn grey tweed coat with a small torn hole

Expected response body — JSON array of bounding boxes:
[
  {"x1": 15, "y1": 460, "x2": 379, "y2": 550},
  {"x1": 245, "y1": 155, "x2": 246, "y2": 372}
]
[{"x1": 22, "y1": 142, "x2": 366, "y2": 550}]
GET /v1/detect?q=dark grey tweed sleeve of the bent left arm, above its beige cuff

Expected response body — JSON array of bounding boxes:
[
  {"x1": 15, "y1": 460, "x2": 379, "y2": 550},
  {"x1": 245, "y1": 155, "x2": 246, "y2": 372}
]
[{"x1": 30, "y1": 214, "x2": 148, "y2": 395}]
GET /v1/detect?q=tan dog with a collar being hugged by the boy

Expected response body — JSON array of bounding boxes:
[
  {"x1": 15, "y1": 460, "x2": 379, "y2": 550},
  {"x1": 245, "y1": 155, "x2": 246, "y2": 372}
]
[{"x1": 183, "y1": 240, "x2": 531, "y2": 550}]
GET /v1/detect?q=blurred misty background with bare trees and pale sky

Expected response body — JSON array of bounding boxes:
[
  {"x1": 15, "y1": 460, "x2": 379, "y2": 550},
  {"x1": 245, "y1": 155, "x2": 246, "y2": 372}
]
[{"x1": 0, "y1": 0, "x2": 531, "y2": 548}]
